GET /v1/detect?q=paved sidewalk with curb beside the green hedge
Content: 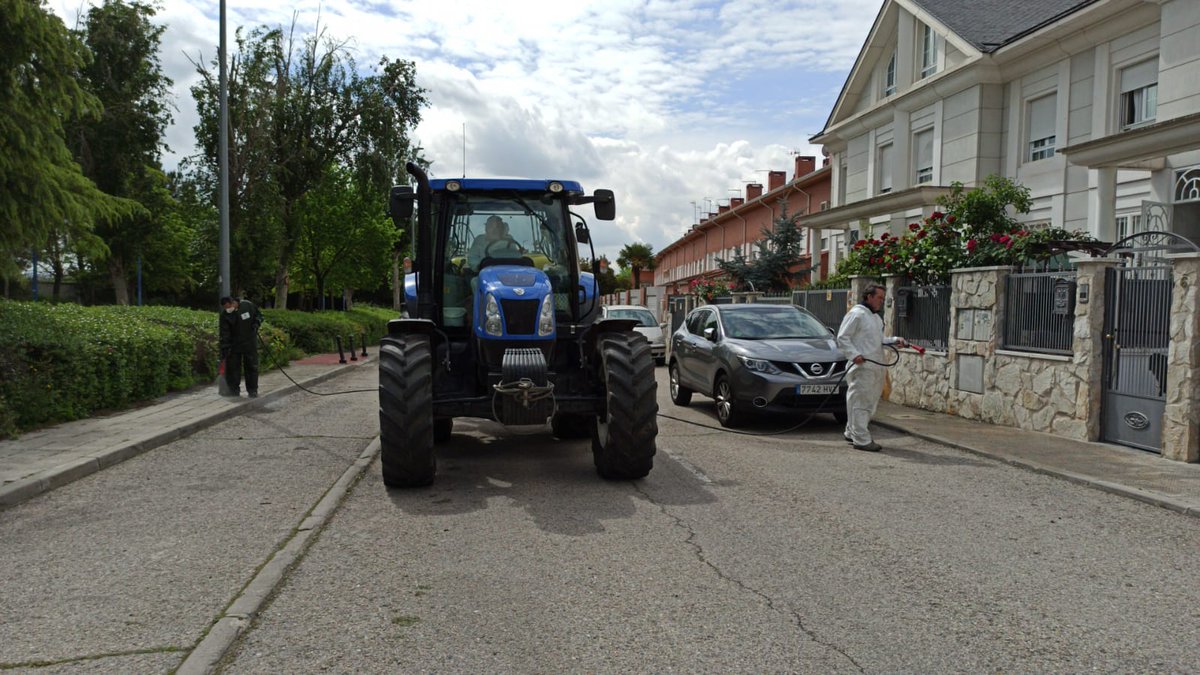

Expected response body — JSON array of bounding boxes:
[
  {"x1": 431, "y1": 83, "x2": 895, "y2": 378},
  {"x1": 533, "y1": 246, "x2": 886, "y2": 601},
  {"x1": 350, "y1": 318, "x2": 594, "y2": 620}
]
[{"x1": 0, "y1": 353, "x2": 374, "y2": 509}]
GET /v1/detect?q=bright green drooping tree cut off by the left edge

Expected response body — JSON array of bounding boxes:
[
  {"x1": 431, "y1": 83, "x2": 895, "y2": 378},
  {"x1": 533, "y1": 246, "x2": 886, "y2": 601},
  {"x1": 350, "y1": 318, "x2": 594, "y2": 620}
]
[{"x1": 0, "y1": 0, "x2": 139, "y2": 285}]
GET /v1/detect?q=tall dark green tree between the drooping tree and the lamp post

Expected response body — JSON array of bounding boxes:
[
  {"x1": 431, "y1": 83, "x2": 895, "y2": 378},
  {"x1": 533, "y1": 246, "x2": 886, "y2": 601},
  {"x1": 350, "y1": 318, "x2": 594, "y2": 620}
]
[{"x1": 68, "y1": 0, "x2": 178, "y2": 305}]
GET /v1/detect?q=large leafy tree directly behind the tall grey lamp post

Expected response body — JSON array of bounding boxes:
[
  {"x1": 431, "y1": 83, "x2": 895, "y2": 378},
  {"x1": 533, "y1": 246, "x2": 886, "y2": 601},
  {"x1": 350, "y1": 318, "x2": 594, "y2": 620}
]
[{"x1": 193, "y1": 26, "x2": 425, "y2": 307}]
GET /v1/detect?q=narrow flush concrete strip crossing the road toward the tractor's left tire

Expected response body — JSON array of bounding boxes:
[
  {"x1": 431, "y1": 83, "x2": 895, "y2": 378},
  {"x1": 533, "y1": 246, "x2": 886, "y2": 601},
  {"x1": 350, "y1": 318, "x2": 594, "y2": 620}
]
[{"x1": 175, "y1": 437, "x2": 379, "y2": 675}]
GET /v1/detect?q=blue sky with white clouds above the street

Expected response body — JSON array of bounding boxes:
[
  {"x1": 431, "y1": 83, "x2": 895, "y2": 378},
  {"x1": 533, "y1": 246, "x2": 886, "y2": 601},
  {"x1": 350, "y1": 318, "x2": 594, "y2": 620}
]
[{"x1": 50, "y1": 0, "x2": 882, "y2": 259}]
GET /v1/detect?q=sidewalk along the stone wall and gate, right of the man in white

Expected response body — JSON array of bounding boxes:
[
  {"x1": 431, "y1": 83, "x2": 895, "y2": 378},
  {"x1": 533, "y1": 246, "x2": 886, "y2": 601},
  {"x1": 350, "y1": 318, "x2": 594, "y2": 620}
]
[{"x1": 874, "y1": 401, "x2": 1200, "y2": 516}]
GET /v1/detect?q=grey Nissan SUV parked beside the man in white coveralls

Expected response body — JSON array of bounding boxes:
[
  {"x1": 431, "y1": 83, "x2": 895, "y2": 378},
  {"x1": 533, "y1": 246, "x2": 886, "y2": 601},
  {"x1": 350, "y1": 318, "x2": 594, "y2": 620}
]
[{"x1": 668, "y1": 304, "x2": 847, "y2": 426}]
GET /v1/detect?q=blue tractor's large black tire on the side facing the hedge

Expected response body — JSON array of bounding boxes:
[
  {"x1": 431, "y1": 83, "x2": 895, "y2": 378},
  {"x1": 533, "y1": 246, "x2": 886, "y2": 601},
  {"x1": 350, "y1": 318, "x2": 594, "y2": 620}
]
[{"x1": 379, "y1": 335, "x2": 437, "y2": 488}]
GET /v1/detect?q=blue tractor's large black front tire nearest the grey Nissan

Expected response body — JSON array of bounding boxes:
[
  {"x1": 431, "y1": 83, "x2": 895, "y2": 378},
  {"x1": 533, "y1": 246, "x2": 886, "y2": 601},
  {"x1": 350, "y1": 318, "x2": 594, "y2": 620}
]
[{"x1": 592, "y1": 333, "x2": 659, "y2": 480}]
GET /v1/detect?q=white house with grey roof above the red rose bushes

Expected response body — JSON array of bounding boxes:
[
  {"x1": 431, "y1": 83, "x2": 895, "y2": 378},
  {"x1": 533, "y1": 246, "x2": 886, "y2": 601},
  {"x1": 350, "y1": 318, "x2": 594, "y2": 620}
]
[{"x1": 806, "y1": 0, "x2": 1200, "y2": 269}]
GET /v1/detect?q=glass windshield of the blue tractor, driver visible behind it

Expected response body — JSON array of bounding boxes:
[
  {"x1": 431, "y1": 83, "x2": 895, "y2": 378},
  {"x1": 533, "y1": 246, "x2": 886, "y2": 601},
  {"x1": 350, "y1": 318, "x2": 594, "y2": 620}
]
[{"x1": 439, "y1": 192, "x2": 570, "y2": 325}]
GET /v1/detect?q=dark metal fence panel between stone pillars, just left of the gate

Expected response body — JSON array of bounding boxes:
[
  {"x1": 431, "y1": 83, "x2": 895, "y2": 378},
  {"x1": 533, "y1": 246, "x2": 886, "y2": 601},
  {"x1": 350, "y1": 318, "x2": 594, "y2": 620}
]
[{"x1": 1001, "y1": 271, "x2": 1075, "y2": 354}]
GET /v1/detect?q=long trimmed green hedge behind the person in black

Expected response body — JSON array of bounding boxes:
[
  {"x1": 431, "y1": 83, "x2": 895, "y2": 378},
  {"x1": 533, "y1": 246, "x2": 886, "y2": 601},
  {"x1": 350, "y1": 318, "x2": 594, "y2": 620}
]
[{"x1": 0, "y1": 299, "x2": 396, "y2": 438}]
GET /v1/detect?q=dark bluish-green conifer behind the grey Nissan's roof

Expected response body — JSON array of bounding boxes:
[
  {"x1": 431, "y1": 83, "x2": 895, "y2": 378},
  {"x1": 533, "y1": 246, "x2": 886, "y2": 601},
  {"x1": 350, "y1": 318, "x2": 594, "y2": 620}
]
[{"x1": 716, "y1": 199, "x2": 811, "y2": 293}]
